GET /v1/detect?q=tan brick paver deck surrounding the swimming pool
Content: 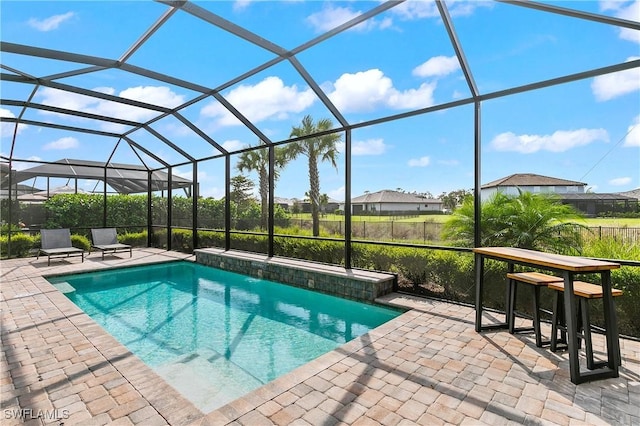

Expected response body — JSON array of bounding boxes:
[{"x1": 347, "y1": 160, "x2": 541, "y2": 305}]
[{"x1": 0, "y1": 249, "x2": 640, "y2": 426}]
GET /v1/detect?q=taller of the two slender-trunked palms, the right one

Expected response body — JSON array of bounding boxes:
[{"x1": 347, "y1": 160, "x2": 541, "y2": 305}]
[{"x1": 287, "y1": 115, "x2": 340, "y2": 237}]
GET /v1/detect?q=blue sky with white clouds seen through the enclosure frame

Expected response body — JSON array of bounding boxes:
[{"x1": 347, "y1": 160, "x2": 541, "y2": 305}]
[{"x1": 0, "y1": 0, "x2": 640, "y2": 201}]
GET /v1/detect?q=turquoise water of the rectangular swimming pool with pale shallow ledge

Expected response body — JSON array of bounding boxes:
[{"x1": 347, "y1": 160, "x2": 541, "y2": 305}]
[{"x1": 49, "y1": 262, "x2": 400, "y2": 412}]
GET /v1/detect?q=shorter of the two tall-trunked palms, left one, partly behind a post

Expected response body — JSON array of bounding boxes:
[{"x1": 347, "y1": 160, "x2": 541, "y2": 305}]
[{"x1": 236, "y1": 141, "x2": 287, "y2": 229}]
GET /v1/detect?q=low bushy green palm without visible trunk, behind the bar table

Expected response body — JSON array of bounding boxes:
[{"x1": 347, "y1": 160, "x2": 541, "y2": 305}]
[{"x1": 443, "y1": 191, "x2": 585, "y2": 254}]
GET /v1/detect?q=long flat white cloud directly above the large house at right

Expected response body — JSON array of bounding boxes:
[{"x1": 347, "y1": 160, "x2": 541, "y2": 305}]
[{"x1": 491, "y1": 129, "x2": 609, "y2": 154}]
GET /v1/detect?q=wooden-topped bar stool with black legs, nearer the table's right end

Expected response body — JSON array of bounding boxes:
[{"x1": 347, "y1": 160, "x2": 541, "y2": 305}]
[{"x1": 548, "y1": 281, "x2": 622, "y2": 370}]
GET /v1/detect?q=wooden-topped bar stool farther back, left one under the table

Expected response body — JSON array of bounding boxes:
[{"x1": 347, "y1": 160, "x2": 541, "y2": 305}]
[{"x1": 507, "y1": 272, "x2": 562, "y2": 348}]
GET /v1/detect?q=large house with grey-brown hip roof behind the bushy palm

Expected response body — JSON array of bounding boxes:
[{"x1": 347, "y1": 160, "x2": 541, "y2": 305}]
[{"x1": 480, "y1": 173, "x2": 639, "y2": 217}]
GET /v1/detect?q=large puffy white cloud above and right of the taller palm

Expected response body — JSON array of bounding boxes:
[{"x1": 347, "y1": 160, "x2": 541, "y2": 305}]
[{"x1": 328, "y1": 69, "x2": 436, "y2": 112}]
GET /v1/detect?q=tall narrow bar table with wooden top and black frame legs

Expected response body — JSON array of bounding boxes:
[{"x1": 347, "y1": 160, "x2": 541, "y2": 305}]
[{"x1": 473, "y1": 247, "x2": 620, "y2": 384}]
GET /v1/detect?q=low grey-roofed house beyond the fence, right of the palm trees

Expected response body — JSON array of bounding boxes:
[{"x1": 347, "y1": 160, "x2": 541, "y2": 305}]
[{"x1": 340, "y1": 189, "x2": 442, "y2": 216}]
